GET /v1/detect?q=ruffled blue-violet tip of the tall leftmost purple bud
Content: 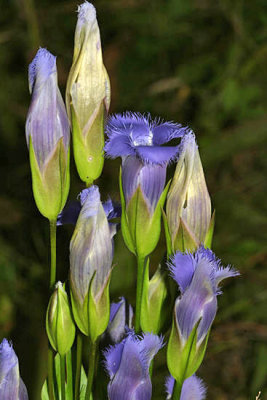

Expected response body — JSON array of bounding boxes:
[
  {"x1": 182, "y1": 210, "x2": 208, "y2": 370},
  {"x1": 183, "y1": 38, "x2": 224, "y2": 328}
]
[{"x1": 28, "y1": 47, "x2": 56, "y2": 92}]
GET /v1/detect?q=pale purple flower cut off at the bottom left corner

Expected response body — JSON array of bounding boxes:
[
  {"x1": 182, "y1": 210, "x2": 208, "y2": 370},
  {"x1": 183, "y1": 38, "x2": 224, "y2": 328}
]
[{"x1": 0, "y1": 339, "x2": 28, "y2": 400}]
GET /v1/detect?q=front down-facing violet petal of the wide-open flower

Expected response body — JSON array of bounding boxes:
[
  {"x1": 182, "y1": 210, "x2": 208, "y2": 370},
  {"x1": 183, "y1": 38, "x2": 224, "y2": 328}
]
[{"x1": 136, "y1": 146, "x2": 179, "y2": 164}]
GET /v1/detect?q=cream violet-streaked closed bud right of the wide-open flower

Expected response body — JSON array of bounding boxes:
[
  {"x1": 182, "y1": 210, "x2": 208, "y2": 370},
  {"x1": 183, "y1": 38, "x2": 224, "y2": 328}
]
[{"x1": 166, "y1": 132, "x2": 214, "y2": 252}]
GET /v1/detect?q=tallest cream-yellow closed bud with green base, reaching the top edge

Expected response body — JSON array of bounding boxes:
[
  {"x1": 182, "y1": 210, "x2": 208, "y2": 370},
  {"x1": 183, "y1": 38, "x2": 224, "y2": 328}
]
[{"x1": 66, "y1": 1, "x2": 110, "y2": 185}]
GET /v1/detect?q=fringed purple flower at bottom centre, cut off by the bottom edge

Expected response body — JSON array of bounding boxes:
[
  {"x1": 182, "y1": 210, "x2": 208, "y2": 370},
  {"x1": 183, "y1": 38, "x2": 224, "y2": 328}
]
[{"x1": 104, "y1": 333, "x2": 163, "y2": 400}]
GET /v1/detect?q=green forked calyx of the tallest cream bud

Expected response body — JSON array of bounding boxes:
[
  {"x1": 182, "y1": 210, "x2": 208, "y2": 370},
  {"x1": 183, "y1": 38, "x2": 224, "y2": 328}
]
[{"x1": 70, "y1": 102, "x2": 105, "y2": 186}]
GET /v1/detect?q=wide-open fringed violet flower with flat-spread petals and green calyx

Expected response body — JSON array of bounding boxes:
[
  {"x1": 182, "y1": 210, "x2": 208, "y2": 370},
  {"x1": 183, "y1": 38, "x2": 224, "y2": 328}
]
[{"x1": 105, "y1": 112, "x2": 187, "y2": 257}]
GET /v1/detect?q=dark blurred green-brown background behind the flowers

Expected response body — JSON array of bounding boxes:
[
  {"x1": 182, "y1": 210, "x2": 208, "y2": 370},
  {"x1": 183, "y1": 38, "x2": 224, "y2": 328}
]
[{"x1": 0, "y1": 0, "x2": 267, "y2": 400}]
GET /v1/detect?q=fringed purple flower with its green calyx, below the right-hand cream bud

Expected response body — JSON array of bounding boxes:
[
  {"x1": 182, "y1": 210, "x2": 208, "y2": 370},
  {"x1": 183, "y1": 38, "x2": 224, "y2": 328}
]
[{"x1": 167, "y1": 246, "x2": 238, "y2": 383}]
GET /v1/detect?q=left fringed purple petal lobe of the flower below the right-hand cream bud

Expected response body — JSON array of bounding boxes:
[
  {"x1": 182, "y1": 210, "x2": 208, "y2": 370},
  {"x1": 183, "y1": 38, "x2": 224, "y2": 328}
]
[{"x1": 168, "y1": 252, "x2": 196, "y2": 293}]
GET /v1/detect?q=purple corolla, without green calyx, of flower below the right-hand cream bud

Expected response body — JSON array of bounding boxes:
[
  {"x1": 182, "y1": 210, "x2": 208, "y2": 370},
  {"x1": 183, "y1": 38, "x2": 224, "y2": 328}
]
[{"x1": 169, "y1": 246, "x2": 239, "y2": 346}]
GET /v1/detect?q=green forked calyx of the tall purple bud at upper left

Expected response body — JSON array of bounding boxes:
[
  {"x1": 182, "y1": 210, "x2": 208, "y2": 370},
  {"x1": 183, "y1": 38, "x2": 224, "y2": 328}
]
[{"x1": 29, "y1": 136, "x2": 70, "y2": 221}]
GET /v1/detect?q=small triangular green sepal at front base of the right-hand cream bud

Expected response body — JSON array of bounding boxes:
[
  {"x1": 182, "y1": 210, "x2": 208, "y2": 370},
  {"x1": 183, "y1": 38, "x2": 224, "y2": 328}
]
[{"x1": 173, "y1": 218, "x2": 199, "y2": 252}]
